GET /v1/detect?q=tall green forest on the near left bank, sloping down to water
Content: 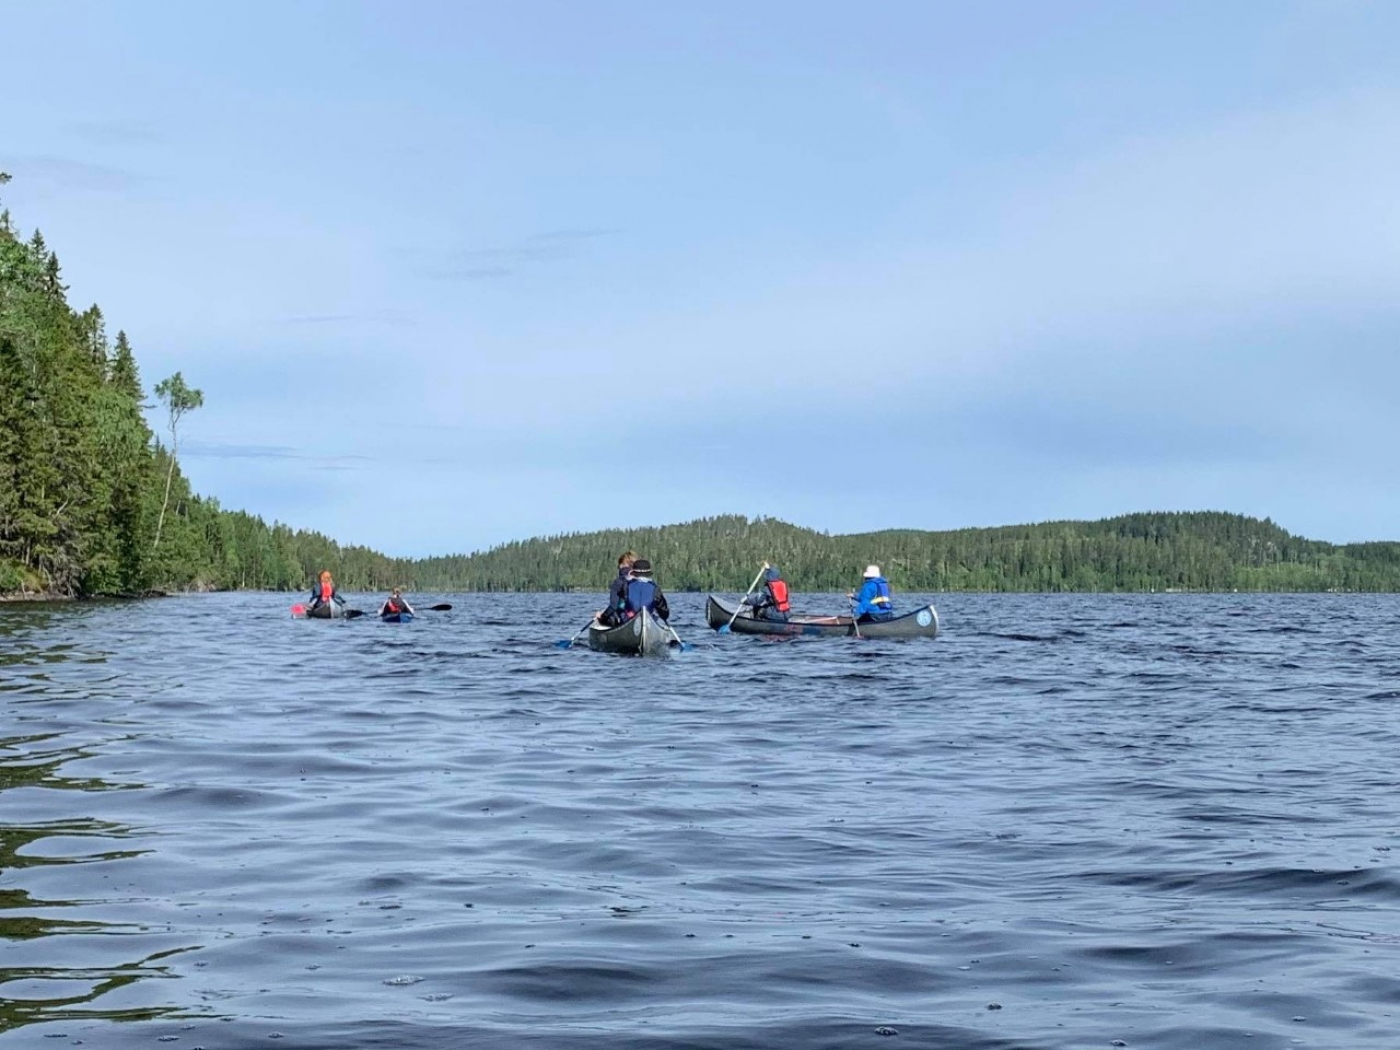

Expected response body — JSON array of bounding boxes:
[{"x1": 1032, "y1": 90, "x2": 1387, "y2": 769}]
[{"x1": 0, "y1": 180, "x2": 403, "y2": 596}]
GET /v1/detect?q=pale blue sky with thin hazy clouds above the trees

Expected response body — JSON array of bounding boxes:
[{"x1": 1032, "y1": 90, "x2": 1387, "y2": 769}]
[{"x1": 0, "y1": 0, "x2": 1400, "y2": 554}]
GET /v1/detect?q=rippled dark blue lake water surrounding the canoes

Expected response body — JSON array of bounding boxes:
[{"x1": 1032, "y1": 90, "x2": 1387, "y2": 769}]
[{"x1": 0, "y1": 594, "x2": 1400, "y2": 1050}]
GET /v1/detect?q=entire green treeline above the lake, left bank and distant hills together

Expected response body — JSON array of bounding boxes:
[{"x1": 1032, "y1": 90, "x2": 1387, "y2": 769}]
[{"x1": 0, "y1": 172, "x2": 1400, "y2": 596}]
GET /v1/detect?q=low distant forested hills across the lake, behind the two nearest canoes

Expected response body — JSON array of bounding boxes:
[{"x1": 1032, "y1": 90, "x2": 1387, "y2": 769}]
[{"x1": 412, "y1": 511, "x2": 1400, "y2": 591}]
